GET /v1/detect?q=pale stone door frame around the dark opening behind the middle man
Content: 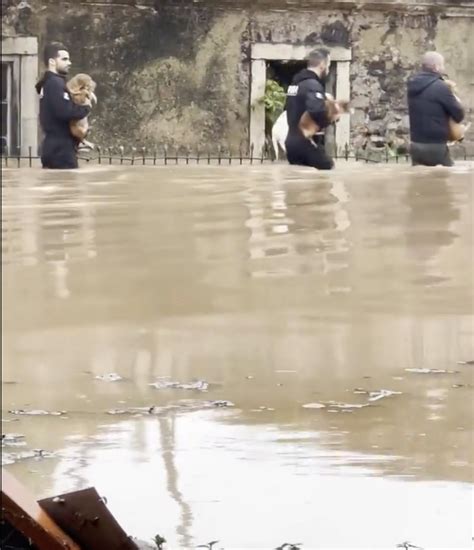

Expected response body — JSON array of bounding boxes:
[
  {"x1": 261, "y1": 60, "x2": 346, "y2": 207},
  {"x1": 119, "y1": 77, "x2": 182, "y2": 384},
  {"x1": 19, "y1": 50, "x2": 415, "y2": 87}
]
[{"x1": 249, "y1": 42, "x2": 352, "y2": 153}]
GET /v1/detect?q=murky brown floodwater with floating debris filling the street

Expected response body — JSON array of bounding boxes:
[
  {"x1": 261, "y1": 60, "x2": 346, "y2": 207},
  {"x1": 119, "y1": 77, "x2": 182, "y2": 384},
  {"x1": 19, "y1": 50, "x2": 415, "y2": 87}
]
[{"x1": 2, "y1": 163, "x2": 474, "y2": 549}]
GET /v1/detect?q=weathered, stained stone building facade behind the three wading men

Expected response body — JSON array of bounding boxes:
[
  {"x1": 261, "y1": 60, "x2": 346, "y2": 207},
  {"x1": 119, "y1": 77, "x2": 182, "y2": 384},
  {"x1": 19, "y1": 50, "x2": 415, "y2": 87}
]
[{"x1": 2, "y1": 0, "x2": 474, "y2": 155}]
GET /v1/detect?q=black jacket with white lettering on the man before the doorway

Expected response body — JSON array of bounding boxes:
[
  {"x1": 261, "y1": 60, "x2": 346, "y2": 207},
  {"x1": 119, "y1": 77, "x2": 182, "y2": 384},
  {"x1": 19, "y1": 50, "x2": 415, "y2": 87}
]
[{"x1": 286, "y1": 69, "x2": 329, "y2": 135}]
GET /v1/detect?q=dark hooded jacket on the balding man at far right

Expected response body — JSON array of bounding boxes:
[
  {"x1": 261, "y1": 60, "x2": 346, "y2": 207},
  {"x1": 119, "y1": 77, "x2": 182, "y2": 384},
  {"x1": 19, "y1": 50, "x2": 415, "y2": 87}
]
[{"x1": 407, "y1": 72, "x2": 464, "y2": 143}]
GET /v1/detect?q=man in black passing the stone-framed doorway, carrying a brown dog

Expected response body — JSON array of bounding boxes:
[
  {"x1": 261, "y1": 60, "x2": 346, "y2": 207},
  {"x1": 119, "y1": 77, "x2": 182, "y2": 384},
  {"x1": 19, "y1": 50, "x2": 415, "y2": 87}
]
[{"x1": 285, "y1": 48, "x2": 334, "y2": 170}]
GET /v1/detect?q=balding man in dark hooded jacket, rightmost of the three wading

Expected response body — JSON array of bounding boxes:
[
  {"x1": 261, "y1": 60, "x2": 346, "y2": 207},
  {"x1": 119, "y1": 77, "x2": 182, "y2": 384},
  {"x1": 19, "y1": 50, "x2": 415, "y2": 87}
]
[{"x1": 407, "y1": 52, "x2": 464, "y2": 166}]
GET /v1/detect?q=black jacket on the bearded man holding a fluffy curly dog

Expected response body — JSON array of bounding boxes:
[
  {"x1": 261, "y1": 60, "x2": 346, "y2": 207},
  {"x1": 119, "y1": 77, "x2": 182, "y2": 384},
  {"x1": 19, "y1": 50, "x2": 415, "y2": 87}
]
[{"x1": 36, "y1": 71, "x2": 90, "y2": 139}]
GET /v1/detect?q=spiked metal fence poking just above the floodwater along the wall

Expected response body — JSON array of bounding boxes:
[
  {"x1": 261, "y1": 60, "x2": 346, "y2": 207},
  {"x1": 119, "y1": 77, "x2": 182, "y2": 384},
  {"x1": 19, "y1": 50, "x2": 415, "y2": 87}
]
[{"x1": 1, "y1": 145, "x2": 474, "y2": 168}]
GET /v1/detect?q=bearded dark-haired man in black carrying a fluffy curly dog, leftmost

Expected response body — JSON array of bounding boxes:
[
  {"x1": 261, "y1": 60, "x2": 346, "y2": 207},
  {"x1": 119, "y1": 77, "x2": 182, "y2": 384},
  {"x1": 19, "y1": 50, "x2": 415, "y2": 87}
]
[{"x1": 36, "y1": 44, "x2": 90, "y2": 169}]
